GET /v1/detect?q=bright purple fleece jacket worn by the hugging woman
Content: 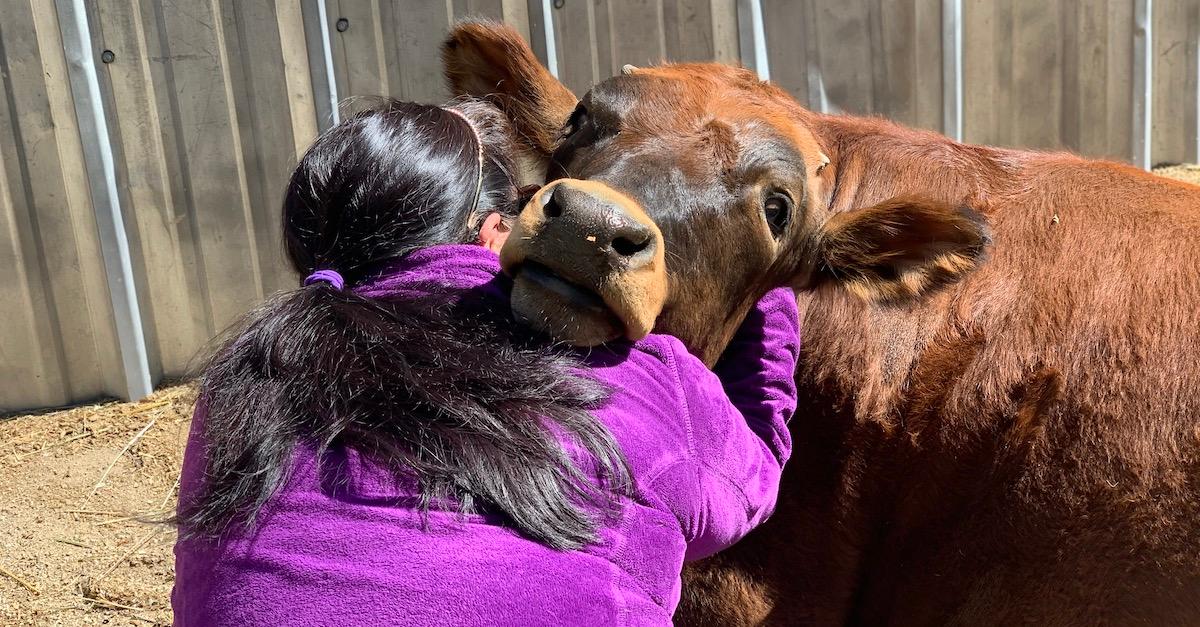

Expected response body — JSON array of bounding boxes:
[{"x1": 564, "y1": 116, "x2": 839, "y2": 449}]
[{"x1": 172, "y1": 245, "x2": 799, "y2": 626}]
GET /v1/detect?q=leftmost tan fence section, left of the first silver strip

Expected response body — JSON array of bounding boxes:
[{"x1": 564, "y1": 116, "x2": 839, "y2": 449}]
[{"x1": 0, "y1": 1, "x2": 124, "y2": 405}]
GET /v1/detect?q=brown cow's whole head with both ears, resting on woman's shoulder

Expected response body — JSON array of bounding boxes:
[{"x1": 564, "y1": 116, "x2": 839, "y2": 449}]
[{"x1": 443, "y1": 22, "x2": 986, "y2": 363}]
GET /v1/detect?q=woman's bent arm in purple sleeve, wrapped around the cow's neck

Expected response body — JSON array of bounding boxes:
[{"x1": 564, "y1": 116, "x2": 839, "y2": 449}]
[{"x1": 650, "y1": 288, "x2": 799, "y2": 560}]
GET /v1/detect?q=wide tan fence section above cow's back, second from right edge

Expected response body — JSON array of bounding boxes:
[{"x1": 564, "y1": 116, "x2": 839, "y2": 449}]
[{"x1": 964, "y1": 0, "x2": 1132, "y2": 160}]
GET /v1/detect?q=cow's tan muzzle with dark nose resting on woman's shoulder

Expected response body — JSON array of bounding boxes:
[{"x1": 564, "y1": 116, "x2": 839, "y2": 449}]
[{"x1": 500, "y1": 179, "x2": 667, "y2": 346}]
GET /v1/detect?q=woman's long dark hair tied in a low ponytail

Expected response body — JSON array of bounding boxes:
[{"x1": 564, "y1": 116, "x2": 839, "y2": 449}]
[{"x1": 178, "y1": 101, "x2": 628, "y2": 549}]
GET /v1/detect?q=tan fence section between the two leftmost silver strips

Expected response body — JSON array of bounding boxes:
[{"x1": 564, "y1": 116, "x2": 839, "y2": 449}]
[{"x1": 96, "y1": 0, "x2": 316, "y2": 375}]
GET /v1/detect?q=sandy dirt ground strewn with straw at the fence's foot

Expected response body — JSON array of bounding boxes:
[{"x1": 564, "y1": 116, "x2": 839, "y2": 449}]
[{"x1": 0, "y1": 166, "x2": 1200, "y2": 625}]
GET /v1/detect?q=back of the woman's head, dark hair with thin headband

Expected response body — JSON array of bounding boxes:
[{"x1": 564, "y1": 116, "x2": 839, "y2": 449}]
[{"x1": 283, "y1": 100, "x2": 518, "y2": 285}]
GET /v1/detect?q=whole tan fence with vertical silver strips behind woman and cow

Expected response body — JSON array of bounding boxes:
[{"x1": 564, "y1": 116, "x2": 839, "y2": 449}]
[{"x1": 0, "y1": 0, "x2": 1200, "y2": 410}]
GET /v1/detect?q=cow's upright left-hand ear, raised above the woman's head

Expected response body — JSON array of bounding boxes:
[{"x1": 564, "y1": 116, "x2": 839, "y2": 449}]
[{"x1": 442, "y1": 19, "x2": 578, "y2": 157}]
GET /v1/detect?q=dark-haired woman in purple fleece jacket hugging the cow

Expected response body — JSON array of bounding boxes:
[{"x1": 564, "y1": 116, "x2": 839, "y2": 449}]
[{"x1": 173, "y1": 102, "x2": 798, "y2": 625}]
